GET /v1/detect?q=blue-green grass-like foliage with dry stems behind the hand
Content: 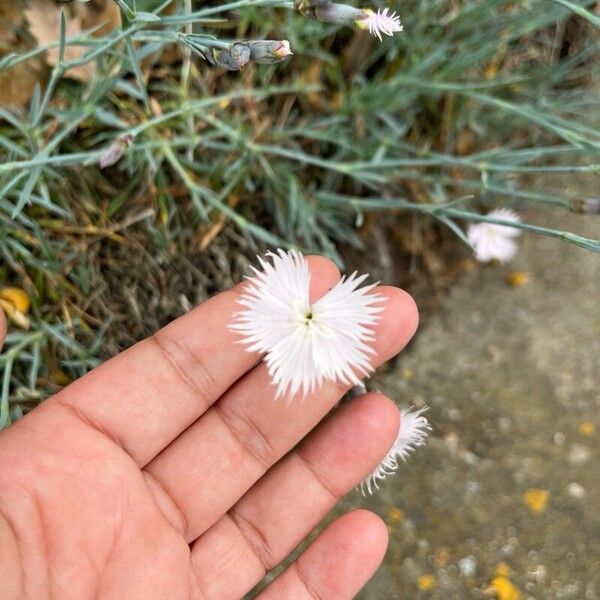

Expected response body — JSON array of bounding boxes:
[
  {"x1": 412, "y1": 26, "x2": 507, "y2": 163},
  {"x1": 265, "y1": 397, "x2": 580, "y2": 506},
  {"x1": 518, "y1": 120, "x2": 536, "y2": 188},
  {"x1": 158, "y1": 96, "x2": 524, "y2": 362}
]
[{"x1": 0, "y1": 0, "x2": 600, "y2": 427}]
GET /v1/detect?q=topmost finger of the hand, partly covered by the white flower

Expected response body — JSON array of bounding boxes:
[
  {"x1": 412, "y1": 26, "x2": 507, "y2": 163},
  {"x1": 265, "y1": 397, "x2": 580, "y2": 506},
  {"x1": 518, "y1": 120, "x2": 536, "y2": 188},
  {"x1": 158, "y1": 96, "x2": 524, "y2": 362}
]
[{"x1": 41, "y1": 256, "x2": 340, "y2": 467}]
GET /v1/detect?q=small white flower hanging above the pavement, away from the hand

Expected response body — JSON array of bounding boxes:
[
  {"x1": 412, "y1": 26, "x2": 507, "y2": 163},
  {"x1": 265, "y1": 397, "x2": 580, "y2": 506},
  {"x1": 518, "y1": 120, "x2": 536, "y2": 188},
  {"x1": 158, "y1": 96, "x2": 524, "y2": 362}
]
[{"x1": 467, "y1": 208, "x2": 521, "y2": 262}]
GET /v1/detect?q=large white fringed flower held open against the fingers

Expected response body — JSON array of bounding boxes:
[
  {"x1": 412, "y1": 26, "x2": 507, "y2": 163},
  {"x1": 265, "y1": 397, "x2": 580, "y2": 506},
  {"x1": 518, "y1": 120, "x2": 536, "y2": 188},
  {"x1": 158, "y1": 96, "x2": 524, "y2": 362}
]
[{"x1": 231, "y1": 250, "x2": 383, "y2": 397}]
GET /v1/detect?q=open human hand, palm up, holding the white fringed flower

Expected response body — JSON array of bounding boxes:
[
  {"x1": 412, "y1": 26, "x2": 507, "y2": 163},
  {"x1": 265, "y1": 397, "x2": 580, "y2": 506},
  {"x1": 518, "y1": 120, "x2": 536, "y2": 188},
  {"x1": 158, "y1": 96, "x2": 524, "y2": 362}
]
[{"x1": 0, "y1": 257, "x2": 417, "y2": 600}]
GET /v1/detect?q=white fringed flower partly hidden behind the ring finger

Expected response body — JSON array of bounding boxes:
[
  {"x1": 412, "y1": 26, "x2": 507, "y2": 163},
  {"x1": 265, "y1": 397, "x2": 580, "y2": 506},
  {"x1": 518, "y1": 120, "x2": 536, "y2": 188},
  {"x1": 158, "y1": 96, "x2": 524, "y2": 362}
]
[{"x1": 360, "y1": 407, "x2": 431, "y2": 494}]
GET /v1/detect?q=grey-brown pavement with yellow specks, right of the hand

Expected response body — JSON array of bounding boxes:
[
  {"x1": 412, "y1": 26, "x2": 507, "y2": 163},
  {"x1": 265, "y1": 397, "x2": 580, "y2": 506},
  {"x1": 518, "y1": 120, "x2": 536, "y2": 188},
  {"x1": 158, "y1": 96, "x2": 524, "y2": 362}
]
[{"x1": 346, "y1": 213, "x2": 600, "y2": 600}]
